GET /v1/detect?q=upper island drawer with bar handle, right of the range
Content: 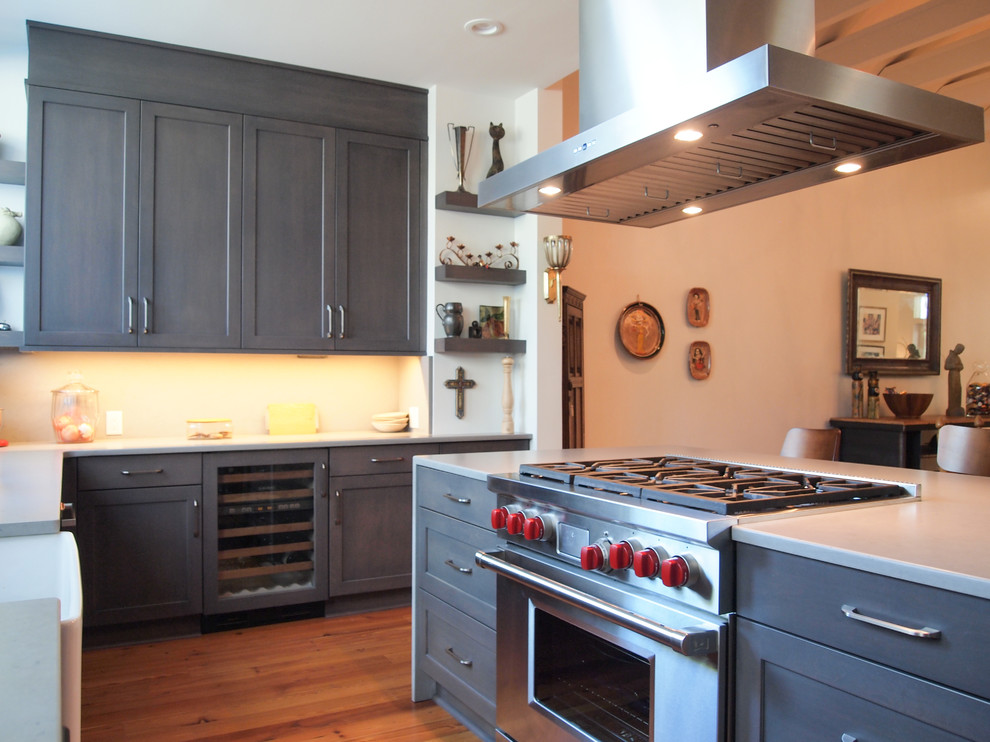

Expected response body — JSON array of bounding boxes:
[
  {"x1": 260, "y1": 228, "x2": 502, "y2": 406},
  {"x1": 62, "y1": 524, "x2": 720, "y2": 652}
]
[{"x1": 736, "y1": 544, "x2": 990, "y2": 698}]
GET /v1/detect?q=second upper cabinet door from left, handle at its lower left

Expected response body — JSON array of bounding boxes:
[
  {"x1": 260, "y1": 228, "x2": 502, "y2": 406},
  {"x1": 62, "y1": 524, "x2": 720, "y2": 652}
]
[{"x1": 137, "y1": 103, "x2": 242, "y2": 349}]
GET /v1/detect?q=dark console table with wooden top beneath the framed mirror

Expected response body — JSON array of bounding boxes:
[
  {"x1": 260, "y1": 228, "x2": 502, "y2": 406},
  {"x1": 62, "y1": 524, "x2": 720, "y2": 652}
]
[{"x1": 829, "y1": 415, "x2": 973, "y2": 469}]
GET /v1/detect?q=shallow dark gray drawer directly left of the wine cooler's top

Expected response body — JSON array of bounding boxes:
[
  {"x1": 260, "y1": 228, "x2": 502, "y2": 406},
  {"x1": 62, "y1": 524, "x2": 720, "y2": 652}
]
[{"x1": 77, "y1": 453, "x2": 203, "y2": 490}]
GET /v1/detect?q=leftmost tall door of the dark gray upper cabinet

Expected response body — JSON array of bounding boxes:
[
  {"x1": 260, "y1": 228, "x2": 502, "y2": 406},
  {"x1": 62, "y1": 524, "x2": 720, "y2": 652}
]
[{"x1": 24, "y1": 86, "x2": 140, "y2": 348}]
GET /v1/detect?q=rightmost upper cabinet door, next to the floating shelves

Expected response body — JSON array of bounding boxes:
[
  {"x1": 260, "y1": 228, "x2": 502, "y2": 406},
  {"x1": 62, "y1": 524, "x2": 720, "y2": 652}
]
[{"x1": 335, "y1": 131, "x2": 426, "y2": 353}]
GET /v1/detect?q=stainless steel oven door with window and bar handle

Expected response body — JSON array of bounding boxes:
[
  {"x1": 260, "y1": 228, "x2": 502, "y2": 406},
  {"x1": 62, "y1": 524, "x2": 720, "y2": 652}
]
[{"x1": 476, "y1": 551, "x2": 727, "y2": 742}]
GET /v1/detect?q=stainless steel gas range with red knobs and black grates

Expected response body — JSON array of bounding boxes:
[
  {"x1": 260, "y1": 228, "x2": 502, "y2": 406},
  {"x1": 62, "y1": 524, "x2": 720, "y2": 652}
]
[{"x1": 476, "y1": 455, "x2": 919, "y2": 742}]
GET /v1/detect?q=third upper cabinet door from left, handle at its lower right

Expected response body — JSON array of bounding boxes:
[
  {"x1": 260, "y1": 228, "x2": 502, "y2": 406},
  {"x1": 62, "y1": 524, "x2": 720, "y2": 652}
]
[{"x1": 242, "y1": 117, "x2": 339, "y2": 350}]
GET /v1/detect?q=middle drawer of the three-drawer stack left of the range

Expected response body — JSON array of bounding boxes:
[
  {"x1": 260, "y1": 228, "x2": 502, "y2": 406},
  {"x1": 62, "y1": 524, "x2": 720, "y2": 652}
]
[{"x1": 416, "y1": 508, "x2": 498, "y2": 628}]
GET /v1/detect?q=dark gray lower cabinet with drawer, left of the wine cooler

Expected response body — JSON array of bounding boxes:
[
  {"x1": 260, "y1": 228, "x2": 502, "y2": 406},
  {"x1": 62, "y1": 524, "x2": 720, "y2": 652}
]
[{"x1": 76, "y1": 454, "x2": 203, "y2": 628}]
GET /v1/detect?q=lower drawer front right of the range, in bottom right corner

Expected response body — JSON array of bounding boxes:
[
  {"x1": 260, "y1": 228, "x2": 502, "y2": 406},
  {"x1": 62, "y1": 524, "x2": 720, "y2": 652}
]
[{"x1": 735, "y1": 619, "x2": 990, "y2": 742}]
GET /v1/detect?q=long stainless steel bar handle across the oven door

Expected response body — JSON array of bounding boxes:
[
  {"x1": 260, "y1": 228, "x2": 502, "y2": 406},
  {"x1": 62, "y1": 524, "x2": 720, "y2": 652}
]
[{"x1": 474, "y1": 551, "x2": 718, "y2": 656}]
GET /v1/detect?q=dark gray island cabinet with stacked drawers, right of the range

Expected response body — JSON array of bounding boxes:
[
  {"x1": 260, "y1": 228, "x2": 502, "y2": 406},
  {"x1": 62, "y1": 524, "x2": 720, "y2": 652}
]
[{"x1": 735, "y1": 544, "x2": 990, "y2": 742}]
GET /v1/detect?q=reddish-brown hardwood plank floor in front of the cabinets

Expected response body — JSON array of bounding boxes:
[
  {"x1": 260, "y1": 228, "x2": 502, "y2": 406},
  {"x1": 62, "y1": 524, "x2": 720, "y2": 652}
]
[{"x1": 82, "y1": 608, "x2": 478, "y2": 742}]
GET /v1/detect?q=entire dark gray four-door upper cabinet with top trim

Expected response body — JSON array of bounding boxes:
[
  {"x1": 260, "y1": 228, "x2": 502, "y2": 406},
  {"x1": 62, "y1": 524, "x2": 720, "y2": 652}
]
[{"x1": 25, "y1": 23, "x2": 426, "y2": 354}]
